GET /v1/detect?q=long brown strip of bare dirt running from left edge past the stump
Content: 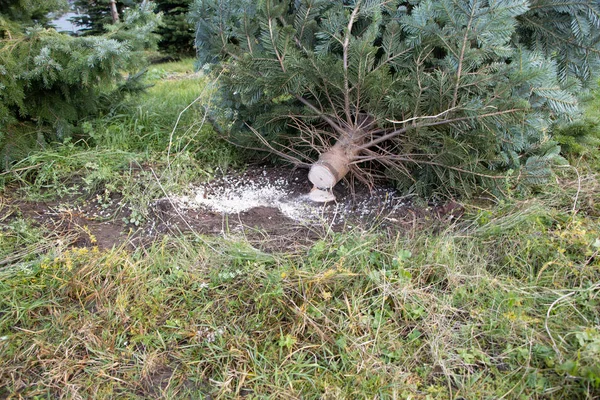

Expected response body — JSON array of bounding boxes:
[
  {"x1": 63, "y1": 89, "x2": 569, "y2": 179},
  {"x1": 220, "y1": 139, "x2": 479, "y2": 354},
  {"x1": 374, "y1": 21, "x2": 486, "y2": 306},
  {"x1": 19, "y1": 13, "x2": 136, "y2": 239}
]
[{"x1": 0, "y1": 167, "x2": 463, "y2": 251}]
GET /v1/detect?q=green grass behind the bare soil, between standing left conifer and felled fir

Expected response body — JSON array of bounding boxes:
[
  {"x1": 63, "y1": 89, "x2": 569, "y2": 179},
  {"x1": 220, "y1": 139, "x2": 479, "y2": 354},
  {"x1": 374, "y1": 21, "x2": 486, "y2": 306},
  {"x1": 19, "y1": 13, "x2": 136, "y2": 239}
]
[{"x1": 0, "y1": 59, "x2": 240, "y2": 205}]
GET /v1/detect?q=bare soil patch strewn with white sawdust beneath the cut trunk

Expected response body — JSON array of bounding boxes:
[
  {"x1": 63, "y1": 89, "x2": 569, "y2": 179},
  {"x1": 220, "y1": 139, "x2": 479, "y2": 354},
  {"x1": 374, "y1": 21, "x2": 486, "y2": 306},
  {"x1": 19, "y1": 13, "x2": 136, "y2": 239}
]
[{"x1": 143, "y1": 167, "x2": 463, "y2": 251}]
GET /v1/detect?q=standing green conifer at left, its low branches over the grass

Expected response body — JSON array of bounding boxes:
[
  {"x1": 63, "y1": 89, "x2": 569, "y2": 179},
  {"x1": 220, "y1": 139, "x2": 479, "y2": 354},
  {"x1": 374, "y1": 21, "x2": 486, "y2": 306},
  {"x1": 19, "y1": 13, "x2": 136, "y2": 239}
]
[{"x1": 0, "y1": 3, "x2": 160, "y2": 168}]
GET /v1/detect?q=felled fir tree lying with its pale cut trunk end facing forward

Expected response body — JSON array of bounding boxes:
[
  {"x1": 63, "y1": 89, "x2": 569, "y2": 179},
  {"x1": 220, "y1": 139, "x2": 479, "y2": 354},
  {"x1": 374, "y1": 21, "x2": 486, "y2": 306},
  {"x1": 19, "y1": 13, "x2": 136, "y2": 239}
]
[{"x1": 193, "y1": 0, "x2": 600, "y2": 192}]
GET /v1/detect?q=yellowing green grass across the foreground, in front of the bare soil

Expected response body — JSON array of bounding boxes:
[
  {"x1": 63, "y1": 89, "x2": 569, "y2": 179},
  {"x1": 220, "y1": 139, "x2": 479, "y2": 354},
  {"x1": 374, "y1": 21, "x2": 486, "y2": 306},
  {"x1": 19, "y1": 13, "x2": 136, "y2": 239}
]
[{"x1": 0, "y1": 204, "x2": 600, "y2": 399}]
